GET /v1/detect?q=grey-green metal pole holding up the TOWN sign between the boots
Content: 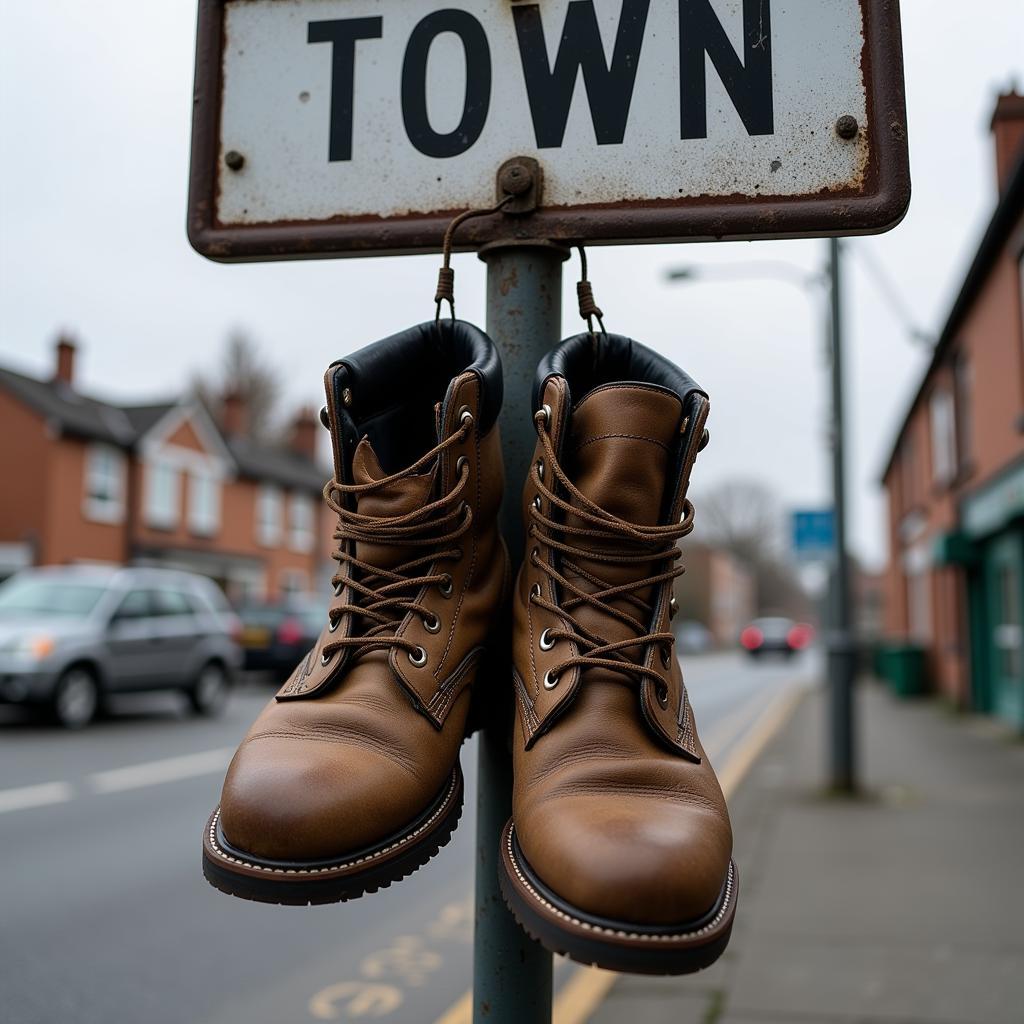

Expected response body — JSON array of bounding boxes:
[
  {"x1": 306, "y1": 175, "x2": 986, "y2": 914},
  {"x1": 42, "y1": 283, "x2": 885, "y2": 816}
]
[{"x1": 473, "y1": 243, "x2": 568, "y2": 1024}]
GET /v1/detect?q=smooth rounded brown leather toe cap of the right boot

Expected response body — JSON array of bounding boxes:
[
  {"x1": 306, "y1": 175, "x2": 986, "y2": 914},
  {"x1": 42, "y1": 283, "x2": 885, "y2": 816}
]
[{"x1": 517, "y1": 795, "x2": 732, "y2": 926}]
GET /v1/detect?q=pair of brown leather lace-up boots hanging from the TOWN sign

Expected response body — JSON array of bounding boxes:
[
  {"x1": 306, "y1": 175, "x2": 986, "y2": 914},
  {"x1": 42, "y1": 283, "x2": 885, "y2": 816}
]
[{"x1": 203, "y1": 321, "x2": 737, "y2": 974}]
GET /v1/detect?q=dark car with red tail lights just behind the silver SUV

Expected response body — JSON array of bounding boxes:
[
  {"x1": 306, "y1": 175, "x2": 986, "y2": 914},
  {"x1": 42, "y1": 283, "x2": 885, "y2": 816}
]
[{"x1": 239, "y1": 596, "x2": 327, "y2": 678}]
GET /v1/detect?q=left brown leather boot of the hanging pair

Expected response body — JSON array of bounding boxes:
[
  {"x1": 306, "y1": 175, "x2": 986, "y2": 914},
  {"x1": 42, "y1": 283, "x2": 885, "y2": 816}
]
[{"x1": 203, "y1": 321, "x2": 510, "y2": 904}]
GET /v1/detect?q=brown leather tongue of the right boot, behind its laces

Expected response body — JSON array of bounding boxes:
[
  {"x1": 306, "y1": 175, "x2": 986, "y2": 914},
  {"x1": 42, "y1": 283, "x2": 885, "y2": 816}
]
[{"x1": 562, "y1": 384, "x2": 683, "y2": 660}]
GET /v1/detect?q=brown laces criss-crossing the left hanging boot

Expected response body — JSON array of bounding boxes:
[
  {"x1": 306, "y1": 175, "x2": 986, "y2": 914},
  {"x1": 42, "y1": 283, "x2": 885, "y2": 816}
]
[{"x1": 321, "y1": 414, "x2": 473, "y2": 665}]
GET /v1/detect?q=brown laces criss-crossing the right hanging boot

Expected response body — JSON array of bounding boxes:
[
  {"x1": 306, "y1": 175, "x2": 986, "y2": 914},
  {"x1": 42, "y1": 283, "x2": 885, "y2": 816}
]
[{"x1": 529, "y1": 410, "x2": 693, "y2": 699}]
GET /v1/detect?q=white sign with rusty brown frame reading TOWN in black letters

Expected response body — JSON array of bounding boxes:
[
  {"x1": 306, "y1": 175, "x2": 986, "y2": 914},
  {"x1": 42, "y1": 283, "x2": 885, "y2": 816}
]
[{"x1": 188, "y1": 0, "x2": 910, "y2": 260}]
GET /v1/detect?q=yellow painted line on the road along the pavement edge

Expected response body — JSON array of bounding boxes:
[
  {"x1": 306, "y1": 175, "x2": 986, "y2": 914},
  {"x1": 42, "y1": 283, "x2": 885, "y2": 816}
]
[{"x1": 435, "y1": 686, "x2": 807, "y2": 1024}]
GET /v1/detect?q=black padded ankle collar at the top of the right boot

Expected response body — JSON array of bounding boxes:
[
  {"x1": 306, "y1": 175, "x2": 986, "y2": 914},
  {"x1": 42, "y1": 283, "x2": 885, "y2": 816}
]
[{"x1": 534, "y1": 333, "x2": 707, "y2": 410}]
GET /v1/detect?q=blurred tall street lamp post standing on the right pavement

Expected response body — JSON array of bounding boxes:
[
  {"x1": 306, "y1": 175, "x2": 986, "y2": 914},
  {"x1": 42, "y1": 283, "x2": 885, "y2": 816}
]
[{"x1": 666, "y1": 245, "x2": 857, "y2": 794}]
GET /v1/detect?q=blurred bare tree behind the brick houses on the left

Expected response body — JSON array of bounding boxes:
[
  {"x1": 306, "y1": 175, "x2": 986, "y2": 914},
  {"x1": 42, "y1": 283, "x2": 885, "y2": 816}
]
[{"x1": 193, "y1": 331, "x2": 281, "y2": 441}]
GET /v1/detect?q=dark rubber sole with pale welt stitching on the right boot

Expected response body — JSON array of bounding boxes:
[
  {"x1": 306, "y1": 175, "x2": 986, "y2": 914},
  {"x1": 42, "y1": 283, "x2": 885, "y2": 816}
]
[{"x1": 498, "y1": 821, "x2": 739, "y2": 975}]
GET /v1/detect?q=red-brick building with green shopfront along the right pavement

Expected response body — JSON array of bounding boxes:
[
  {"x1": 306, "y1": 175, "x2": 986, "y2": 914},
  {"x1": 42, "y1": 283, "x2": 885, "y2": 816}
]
[{"x1": 883, "y1": 92, "x2": 1024, "y2": 729}]
